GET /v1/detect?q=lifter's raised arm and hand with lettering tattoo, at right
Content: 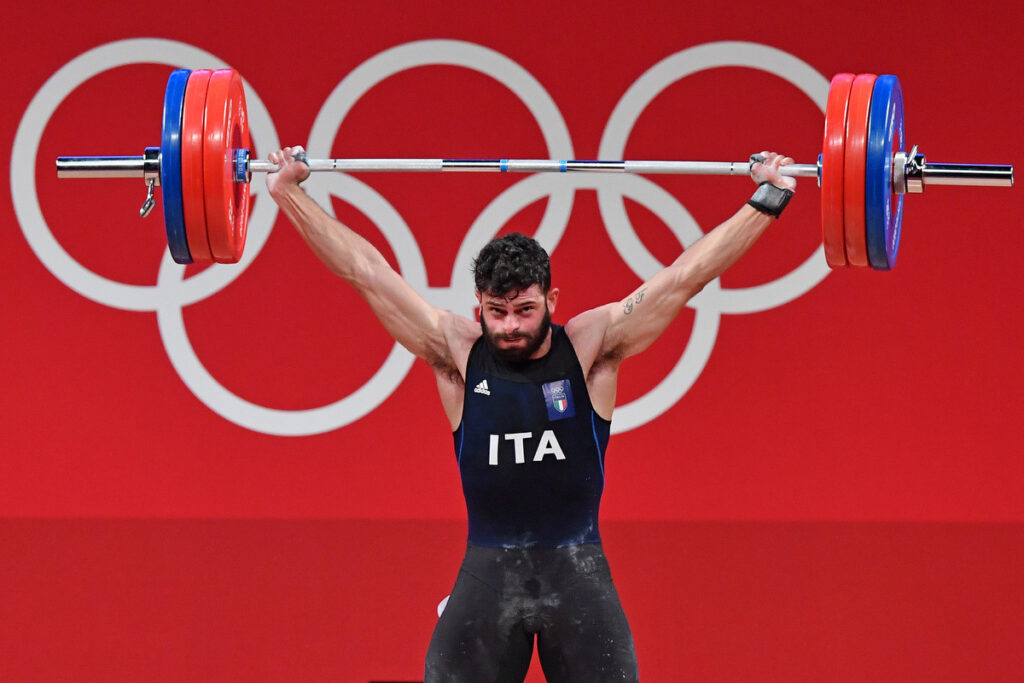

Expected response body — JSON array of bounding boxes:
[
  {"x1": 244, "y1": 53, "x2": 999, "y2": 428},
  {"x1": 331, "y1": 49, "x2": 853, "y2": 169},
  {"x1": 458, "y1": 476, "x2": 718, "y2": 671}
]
[{"x1": 566, "y1": 153, "x2": 796, "y2": 377}]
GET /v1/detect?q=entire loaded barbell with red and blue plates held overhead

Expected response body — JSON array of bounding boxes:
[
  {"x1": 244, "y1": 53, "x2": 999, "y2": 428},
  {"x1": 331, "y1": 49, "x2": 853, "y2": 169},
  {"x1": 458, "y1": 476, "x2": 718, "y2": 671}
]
[{"x1": 56, "y1": 69, "x2": 1014, "y2": 270}]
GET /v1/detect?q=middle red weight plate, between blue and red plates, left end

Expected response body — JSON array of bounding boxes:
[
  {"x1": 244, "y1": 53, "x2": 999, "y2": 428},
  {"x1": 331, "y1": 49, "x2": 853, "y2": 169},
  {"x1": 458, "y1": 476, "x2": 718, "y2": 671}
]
[{"x1": 181, "y1": 69, "x2": 213, "y2": 263}]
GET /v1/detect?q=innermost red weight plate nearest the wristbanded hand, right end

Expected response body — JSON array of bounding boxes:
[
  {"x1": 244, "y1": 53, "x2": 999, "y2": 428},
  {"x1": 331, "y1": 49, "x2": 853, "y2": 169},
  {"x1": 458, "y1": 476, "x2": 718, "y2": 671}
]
[{"x1": 821, "y1": 74, "x2": 854, "y2": 268}]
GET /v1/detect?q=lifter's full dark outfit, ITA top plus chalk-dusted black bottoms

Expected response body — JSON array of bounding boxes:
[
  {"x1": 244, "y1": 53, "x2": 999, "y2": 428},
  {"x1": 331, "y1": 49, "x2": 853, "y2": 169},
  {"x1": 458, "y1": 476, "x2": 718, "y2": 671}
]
[{"x1": 424, "y1": 326, "x2": 638, "y2": 683}]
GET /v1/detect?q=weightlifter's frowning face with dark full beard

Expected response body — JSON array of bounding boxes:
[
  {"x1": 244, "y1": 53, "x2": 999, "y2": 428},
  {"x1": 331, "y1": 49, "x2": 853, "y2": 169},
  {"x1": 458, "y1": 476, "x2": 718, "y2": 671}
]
[{"x1": 476, "y1": 285, "x2": 558, "y2": 362}]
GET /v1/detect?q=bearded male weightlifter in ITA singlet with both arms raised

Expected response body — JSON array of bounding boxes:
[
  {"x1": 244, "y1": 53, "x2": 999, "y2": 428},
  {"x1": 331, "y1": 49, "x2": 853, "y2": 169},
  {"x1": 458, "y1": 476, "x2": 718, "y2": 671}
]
[{"x1": 266, "y1": 147, "x2": 796, "y2": 683}]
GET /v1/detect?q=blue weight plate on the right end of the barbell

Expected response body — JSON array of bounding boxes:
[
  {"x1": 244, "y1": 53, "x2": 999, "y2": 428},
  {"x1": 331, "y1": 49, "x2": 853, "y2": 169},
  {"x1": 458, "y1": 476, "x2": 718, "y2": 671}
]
[{"x1": 864, "y1": 76, "x2": 905, "y2": 270}]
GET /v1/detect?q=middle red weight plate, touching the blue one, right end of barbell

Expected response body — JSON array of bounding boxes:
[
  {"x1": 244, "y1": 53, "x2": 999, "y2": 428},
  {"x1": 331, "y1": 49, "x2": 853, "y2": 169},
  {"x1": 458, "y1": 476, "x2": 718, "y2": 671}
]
[{"x1": 843, "y1": 74, "x2": 878, "y2": 266}]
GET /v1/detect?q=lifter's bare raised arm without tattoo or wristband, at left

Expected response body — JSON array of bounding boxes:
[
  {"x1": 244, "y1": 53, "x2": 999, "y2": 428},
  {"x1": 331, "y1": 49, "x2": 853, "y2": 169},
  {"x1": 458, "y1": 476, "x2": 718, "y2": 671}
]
[{"x1": 266, "y1": 147, "x2": 478, "y2": 374}]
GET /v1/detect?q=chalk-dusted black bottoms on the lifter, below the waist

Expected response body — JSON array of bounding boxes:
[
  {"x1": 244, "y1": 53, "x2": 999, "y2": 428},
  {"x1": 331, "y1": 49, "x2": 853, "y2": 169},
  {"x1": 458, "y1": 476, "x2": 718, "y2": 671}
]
[{"x1": 424, "y1": 543, "x2": 638, "y2": 683}]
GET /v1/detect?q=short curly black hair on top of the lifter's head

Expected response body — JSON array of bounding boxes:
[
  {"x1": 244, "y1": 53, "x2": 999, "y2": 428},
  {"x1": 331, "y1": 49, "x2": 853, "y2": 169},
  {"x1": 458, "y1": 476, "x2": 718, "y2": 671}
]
[{"x1": 473, "y1": 232, "x2": 551, "y2": 297}]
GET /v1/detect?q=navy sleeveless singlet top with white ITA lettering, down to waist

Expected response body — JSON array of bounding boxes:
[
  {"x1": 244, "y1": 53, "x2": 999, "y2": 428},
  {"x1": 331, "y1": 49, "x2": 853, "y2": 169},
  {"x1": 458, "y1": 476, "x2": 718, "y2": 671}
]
[{"x1": 453, "y1": 325, "x2": 611, "y2": 548}]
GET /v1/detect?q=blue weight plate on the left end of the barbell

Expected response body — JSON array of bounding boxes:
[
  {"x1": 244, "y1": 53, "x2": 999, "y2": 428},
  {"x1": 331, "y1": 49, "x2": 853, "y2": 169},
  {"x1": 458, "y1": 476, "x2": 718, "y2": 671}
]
[{"x1": 160, "y1": 69, "x2": 193, "y2": 263}]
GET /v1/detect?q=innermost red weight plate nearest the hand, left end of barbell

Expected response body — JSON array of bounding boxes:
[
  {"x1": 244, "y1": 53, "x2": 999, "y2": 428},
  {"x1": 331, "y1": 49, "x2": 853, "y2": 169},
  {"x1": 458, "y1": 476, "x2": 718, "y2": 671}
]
[{"x1": 203, "y1": 69, "x2": 251, "y2": 263}]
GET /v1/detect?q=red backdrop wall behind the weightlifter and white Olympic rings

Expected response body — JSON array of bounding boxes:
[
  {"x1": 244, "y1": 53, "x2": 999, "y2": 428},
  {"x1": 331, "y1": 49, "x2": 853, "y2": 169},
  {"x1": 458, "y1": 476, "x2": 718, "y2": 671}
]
[{"x1": 0, "y1": 2, "x2": 1024, "y2": 681}]
